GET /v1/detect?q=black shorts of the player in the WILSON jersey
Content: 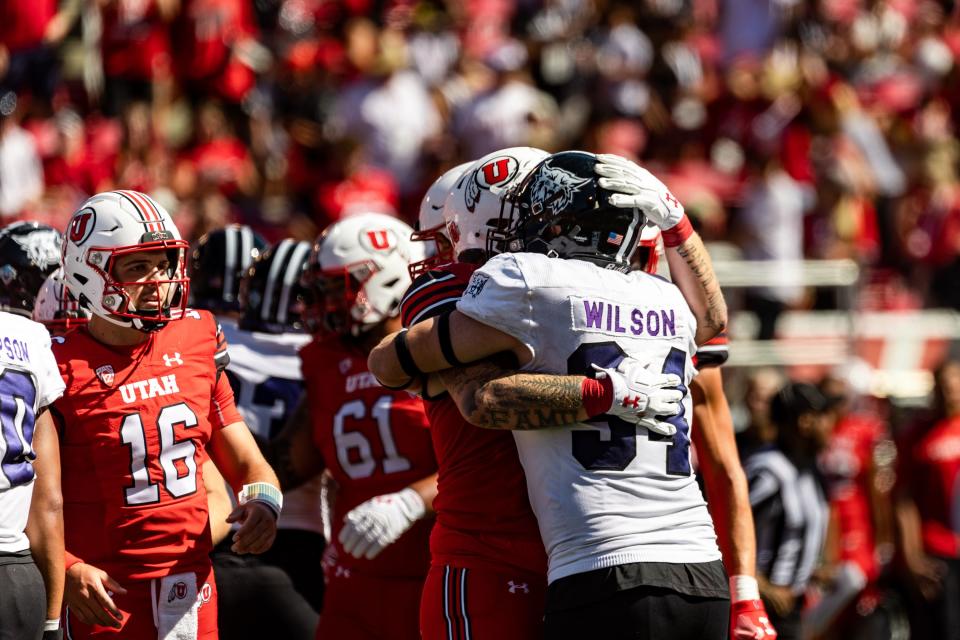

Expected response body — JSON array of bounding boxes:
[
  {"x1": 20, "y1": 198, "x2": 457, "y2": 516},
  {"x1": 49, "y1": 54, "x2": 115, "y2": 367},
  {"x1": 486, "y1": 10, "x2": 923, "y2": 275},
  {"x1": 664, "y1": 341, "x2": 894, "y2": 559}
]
[{"x1": 545, "y1": 560, "x2": 730, "y2": 640}]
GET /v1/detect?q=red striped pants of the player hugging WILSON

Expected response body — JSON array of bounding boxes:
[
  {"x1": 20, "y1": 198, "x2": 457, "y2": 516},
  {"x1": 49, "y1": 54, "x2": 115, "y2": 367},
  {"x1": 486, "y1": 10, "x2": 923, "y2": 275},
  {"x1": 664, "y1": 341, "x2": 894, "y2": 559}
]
[{"x1": 420, "y1": 565, "x2": 547, "y2": 640}]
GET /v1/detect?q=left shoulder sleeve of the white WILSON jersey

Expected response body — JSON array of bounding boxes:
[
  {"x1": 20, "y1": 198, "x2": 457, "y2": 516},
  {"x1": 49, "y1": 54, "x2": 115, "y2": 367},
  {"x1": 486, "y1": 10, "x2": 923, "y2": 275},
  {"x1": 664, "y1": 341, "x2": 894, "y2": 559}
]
[{"x1": 457, "y1": 253, "x2": 537, "y2": 355}]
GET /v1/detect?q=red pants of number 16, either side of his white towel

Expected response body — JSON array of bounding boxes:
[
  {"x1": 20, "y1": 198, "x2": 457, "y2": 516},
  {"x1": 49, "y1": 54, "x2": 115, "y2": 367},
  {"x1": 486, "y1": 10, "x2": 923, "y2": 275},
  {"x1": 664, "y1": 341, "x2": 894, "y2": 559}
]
[{"x1": 63, "y1": 568, "x2": 218, "y2": 640}]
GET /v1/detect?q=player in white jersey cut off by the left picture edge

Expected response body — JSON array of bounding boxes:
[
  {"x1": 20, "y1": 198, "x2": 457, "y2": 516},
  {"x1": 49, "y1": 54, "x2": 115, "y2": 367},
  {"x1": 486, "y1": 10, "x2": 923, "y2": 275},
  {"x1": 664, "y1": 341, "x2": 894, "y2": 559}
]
[{"x1": 0, "y1": 311, "x2": 64, "y2": 638}]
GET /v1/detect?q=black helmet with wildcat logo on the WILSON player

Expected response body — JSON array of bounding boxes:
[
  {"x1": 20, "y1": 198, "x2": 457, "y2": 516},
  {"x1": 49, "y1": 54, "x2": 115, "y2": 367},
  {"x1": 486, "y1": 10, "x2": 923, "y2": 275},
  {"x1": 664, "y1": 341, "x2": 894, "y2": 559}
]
[{"x1": 487, "y1": 151, "x2": 645, "y2": 272}]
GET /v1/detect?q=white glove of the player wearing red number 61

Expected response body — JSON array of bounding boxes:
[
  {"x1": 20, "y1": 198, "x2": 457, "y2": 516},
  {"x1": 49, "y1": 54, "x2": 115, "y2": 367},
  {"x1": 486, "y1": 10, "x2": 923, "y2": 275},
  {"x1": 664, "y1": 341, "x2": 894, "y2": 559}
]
[{"x1": 339, "y1": 487, "x2": 427, "y2": 560}]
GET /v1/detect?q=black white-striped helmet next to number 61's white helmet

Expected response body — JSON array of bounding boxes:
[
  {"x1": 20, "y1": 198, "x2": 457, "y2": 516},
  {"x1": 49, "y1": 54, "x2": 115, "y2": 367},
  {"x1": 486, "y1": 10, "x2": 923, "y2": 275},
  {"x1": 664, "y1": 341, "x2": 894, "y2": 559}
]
[{"x1": 240, "y1": 238, "x2": 310, "y2": 333}]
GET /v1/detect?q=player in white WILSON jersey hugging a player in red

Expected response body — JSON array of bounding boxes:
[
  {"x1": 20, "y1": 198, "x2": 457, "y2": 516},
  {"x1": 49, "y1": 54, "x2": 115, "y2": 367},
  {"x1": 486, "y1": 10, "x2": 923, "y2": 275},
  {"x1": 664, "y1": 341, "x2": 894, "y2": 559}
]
[{"x1": 371, "y1": 152, "x2": 730, "y2": 639}]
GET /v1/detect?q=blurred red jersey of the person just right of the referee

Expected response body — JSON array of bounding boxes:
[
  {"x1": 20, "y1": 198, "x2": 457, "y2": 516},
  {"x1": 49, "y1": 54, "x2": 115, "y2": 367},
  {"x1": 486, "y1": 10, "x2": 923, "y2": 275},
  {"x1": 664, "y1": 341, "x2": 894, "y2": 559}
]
[{"x1": 819, "y1": 415, "x2": 884, "y2": 580}]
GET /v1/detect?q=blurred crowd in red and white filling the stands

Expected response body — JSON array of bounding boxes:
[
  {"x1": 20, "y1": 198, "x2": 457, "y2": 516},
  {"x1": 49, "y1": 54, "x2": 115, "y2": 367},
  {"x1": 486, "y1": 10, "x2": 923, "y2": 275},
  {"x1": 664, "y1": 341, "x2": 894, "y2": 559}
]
[{"x1": 0, "y1": 0, "x2": 960, "y2": 324}]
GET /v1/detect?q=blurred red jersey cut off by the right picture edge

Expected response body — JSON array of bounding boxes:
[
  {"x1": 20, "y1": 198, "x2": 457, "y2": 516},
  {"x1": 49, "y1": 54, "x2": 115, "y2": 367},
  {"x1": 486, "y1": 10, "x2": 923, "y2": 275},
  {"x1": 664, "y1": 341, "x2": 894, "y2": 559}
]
[{"x1": 897, "y1": 417, "x2": 960, "y2": 558}]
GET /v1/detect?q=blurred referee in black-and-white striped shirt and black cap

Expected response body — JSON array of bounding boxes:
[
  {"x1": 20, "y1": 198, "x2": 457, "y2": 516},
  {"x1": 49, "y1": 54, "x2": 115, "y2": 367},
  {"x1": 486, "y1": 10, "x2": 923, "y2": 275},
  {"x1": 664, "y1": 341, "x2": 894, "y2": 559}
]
[{"x1": 743, "y1": 383, "x2": 833, "y2": 640}]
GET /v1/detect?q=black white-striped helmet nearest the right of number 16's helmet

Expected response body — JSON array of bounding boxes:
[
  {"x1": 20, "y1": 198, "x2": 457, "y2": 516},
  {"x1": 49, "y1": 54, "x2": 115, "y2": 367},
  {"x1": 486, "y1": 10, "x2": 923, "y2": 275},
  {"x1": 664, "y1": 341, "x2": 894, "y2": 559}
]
[{"x1": 190, "y1": 224, "x2": 267, "y2": 313}]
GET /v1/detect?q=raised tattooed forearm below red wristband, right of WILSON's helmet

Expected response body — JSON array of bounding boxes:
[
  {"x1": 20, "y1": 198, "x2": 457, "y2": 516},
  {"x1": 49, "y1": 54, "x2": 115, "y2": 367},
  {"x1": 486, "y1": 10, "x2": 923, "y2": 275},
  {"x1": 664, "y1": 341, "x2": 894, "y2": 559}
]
[{"x1": 665, "y1": 233, "x2": 727, "y2": 344}]
